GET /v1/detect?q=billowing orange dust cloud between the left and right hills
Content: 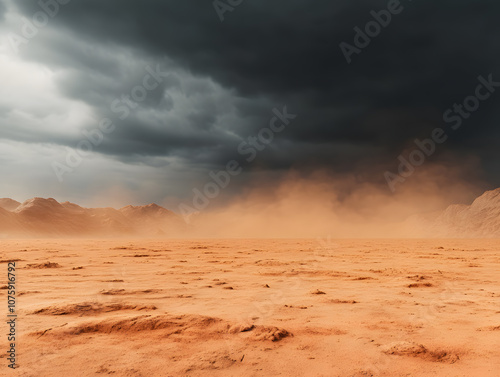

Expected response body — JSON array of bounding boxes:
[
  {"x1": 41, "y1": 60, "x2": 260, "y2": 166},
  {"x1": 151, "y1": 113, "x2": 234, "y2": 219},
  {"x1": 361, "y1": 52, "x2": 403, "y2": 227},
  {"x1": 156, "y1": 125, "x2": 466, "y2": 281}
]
[{"x1": 188, "y1": 169, "x2": 494, "y2": 238}]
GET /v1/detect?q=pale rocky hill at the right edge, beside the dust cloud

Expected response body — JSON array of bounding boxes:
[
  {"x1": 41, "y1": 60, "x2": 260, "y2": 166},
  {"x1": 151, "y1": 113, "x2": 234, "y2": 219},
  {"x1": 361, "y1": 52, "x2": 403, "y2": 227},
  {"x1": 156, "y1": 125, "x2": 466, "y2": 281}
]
[{"x1": 407, "y1": 188, "x2": 500, "y2": 238}]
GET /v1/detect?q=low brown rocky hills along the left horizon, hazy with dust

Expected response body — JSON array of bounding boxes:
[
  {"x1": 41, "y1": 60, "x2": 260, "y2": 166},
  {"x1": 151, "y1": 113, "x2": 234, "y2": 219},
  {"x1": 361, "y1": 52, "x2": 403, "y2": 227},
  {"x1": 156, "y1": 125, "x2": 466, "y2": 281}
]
[{"x1": 0, "y1": 198, "x2": 186, "y2": 237}]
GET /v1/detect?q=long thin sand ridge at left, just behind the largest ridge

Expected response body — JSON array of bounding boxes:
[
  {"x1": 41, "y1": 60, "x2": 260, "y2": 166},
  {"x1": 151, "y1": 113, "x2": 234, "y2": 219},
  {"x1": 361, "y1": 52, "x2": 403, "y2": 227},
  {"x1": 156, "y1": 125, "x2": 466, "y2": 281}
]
[{"x1": 31, "y1": 302, "x2": 157, "y2": 316}]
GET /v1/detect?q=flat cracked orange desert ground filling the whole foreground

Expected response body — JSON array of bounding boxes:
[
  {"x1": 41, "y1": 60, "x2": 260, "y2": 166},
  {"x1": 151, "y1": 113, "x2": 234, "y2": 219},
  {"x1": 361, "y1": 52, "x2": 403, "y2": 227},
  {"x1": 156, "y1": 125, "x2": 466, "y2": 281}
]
[{"x1": 0, "y1": 239, "x2": 500, "y2": 377}]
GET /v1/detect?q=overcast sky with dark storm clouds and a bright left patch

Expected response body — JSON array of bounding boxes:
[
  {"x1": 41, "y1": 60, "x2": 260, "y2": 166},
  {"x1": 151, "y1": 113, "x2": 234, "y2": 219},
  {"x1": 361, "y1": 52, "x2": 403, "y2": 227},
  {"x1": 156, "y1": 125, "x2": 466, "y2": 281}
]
[{"x1": 0, "y1": 0, "x2": 500, "y2": 209}]
